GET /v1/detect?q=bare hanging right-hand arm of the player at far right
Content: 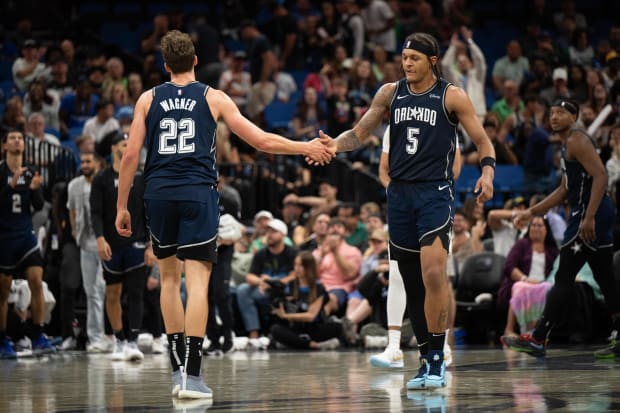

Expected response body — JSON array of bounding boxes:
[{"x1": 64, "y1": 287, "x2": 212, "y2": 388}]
[{"x1": 566, "y1": 131, "x2": 607, "y2": 241}]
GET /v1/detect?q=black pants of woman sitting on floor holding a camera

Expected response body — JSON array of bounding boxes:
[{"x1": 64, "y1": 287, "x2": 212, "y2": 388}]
[{"x1": 271, "y1": 323, "x2": 342, "y2": 349}]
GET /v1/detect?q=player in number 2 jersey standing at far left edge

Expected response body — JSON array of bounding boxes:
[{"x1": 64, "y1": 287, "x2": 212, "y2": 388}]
[{"x1": 0, "y1": 130, "x2": 55, "y2": 358}]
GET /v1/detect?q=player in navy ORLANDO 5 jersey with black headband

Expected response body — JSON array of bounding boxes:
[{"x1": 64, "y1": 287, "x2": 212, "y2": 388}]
[{"x1": 320, "y1": 33, "x2": 495, "y2": 389}]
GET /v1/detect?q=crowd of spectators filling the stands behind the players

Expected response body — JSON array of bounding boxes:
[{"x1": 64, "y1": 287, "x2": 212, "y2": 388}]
[{"x1": 0, "y1": 0, "x2": 620, "y2": 348}]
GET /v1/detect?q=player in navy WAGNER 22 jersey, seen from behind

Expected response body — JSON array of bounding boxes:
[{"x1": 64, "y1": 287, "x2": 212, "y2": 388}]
[{"x1": 116, "y1": 30, "x2": 333, "y2": 399}]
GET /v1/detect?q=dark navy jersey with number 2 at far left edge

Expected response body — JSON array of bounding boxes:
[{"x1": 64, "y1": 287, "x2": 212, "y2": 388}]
[{"x1": 0, "y1": 161, "x2": 43, "y2": 236}]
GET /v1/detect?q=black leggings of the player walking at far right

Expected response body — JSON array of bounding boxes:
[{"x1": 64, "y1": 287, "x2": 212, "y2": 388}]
[{"x1": 534, "y1": 239, "x2": 620, "y2": 341}]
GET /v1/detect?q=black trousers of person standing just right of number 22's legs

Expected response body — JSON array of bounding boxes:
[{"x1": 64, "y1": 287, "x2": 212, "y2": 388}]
[{"x1": 207, "y1": 246, "x2": 233, "y2": 342}]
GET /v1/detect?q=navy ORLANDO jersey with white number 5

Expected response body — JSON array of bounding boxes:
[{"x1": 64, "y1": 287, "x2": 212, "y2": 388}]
[{"x1": 389, "y1": 78, "x2": 458, "y2": 182}]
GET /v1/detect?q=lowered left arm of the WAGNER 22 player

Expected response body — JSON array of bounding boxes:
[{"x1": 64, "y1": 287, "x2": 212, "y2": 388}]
[{"x1": 116, "y1": 90, "x2": 153, "y2": 237}]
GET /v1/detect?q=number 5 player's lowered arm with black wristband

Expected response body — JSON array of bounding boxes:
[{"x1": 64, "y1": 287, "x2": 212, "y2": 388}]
[{"x1": 446, "y1": 86, "x2": 495, "y2": 203}]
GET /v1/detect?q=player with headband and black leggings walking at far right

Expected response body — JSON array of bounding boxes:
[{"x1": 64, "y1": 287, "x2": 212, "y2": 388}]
[{"x1": 502, "y1": 99, "x2": 620, "y2": 358}]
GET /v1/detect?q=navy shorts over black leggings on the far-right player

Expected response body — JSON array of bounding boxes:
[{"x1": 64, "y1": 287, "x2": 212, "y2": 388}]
[{"x1": 562, "y1": 195, "x2": 616, "y2": 250}]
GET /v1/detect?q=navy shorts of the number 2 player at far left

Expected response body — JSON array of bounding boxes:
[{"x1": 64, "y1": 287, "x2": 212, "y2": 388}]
[{"x1": 0, "y1": 232, "x2": 43, "y2": 277}]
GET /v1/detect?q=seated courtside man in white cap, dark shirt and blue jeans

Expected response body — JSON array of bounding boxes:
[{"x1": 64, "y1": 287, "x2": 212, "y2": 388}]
[{"x1": 237, "y1": 219, "x2": 297, "y2": 346}]
